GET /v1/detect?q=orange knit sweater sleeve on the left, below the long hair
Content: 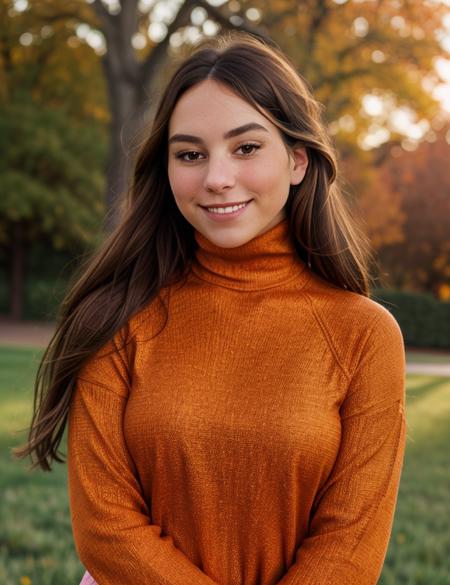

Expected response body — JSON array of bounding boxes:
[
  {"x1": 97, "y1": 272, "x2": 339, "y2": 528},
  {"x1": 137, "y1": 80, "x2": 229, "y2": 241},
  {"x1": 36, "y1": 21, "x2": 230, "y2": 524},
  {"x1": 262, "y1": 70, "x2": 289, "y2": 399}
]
[{"x1": 67, "y1": 330, "x2": 220, "y2": 585}]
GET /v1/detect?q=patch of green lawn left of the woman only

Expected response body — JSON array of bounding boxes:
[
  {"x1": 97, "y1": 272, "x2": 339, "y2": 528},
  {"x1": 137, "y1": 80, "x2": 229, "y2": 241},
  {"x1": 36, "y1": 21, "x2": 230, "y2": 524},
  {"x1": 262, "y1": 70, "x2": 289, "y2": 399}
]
[{"x1": 0, "y1": 347, "x2": 83, "y2": 585}]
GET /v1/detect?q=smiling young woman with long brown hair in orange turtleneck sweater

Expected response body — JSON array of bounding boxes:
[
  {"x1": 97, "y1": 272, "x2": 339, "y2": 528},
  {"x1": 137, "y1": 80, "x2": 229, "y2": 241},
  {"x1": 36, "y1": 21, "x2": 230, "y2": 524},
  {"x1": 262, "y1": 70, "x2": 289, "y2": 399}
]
[{"x1": 15, "y1": 33, "x2": 405, "y2": 585}]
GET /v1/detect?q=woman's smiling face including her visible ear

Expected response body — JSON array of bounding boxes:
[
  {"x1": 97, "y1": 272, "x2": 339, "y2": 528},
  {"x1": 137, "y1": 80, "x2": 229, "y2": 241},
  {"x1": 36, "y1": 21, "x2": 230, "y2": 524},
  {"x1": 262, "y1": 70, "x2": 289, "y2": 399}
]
[{"x1": 168, "y1": 80, "x2": 308, "y2": 248}]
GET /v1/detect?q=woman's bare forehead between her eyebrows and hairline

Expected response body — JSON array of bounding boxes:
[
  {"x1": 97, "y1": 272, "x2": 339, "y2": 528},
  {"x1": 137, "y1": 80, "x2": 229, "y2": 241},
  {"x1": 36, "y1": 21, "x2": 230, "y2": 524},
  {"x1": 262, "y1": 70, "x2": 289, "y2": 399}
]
[{"x1": 169, "y1": 79, "x2": 275, "y2": 135}]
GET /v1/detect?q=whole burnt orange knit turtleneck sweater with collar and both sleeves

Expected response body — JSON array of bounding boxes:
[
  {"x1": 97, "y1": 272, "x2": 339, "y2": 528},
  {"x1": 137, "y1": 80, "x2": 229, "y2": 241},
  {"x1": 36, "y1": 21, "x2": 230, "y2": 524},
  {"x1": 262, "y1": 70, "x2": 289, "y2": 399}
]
[{"x1": 68, "y1": 220, "x2": 405, "y2": 585}]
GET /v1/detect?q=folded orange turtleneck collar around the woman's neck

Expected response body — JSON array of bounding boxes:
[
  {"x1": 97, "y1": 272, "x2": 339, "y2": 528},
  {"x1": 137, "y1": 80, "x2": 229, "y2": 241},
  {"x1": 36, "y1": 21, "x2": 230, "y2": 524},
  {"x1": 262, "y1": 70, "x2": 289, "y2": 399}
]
[{"x1": 192, "y1": 218, "x2": 309, "y2": 291}]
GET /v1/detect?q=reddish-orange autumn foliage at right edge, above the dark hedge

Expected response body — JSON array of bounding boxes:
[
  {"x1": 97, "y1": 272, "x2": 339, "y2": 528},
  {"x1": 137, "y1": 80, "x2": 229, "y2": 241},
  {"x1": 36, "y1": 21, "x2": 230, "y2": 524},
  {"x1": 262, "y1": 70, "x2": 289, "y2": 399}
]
[{"x1": 360, "y1": 126, "x2": 450, "y2": 299}]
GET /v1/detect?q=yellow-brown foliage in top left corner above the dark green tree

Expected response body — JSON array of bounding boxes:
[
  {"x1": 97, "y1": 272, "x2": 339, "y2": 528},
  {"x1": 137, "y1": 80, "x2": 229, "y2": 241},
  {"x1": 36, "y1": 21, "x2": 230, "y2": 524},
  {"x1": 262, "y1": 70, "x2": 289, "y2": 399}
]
[{"x1": 0, "y1": 0, "x2": 110, "y2": 118}]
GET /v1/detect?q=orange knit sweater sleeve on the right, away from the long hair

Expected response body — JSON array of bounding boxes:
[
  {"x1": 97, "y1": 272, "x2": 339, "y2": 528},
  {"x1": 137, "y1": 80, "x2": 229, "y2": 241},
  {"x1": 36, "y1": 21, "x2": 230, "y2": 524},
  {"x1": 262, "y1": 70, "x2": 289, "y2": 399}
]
[{"x1": 278, "y1": 309, "x2": 406, "y2": 585}]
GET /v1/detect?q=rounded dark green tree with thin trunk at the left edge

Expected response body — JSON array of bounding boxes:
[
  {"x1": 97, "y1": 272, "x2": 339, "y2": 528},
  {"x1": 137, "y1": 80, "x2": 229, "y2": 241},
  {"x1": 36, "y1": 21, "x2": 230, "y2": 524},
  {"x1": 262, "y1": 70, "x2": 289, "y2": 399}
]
[{"x1": 0, "y1": 101, "x2": 106, "y2": 319}]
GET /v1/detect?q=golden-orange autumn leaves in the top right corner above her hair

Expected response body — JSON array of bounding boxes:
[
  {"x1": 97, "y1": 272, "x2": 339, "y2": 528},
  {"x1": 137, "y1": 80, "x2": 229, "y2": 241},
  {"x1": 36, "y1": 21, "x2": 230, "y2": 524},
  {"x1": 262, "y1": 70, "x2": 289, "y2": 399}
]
[{"x1": 262, "y1": 0, "x2": 448, "y2": 127}]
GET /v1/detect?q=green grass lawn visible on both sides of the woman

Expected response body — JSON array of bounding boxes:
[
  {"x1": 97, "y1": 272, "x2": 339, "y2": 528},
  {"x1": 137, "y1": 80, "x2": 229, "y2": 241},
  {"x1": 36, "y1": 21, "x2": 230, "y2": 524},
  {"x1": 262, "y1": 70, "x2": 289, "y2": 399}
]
[{"x1": 0, "y1": 348, "x2": 450, "y2": 585}]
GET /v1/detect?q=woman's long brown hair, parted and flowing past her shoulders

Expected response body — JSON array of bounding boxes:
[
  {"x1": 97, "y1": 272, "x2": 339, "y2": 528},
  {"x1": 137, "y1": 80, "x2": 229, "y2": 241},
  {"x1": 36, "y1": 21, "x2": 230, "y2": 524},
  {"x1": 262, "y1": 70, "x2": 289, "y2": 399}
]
[{"x1": 14, "y1": 32, "x2": 372, "y2": 471}]
